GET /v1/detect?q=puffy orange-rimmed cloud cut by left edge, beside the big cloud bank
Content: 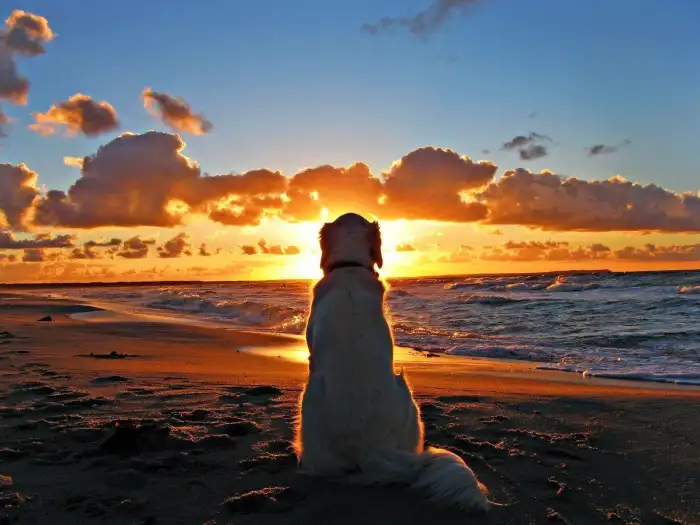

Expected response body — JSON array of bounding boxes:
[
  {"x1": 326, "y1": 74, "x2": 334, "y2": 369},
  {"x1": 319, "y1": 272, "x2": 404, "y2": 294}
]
[{"x1": 0, "y1": 164, "x2": 39, "y2": 230}]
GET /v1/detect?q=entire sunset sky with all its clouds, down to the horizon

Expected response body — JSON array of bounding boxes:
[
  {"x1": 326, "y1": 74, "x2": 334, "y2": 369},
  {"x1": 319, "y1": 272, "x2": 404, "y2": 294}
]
[{"x1": 0, "y1": 0, "x2": 700, "y2": 282}]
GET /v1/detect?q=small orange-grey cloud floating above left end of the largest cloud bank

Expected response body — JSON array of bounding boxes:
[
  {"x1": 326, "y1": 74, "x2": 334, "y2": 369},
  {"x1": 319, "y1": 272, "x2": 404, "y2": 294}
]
[{"x1": 29, "y1": 93, "x2": 119, "y2": 137}]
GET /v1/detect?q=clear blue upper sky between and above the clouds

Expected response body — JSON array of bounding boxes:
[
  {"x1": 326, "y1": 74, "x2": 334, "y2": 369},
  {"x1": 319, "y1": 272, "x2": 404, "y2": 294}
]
[{"x1": 0, "y1": 0, "x2": 700, "y2": 191}]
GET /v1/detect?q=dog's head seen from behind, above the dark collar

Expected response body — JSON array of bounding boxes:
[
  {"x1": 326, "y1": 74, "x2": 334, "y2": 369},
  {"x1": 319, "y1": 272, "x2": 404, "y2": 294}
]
[{"x1": 320, "y1": 213, "x2": 384, "y2": 273}]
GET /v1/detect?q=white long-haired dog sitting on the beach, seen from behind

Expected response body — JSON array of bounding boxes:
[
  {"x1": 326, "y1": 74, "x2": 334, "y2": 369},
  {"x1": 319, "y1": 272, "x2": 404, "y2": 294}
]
[{"x1": 296, "y1": 213, "x2": 489, "y2": 511}]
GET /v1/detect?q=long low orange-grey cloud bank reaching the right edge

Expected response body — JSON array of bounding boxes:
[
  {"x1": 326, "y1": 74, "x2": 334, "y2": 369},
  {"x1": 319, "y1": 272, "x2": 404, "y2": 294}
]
[{"x1": 477, "y1": 169, "x2": 700, "y2": 232}]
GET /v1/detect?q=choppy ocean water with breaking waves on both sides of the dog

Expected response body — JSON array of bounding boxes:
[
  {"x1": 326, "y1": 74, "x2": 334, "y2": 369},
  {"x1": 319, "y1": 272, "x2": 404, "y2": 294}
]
[{"x1": 26, "y1": 271, "x2": 700, "y2": 385}]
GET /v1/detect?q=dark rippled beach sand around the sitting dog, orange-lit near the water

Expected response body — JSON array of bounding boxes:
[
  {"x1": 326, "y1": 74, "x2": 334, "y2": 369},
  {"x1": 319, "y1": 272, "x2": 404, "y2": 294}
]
[{"x1": 0, "y1": 294, "x2": 700, "y2": 525}]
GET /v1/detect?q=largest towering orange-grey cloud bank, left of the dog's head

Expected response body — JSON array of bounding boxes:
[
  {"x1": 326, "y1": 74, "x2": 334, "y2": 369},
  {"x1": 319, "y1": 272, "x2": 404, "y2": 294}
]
[{"x1": 36, "y1": 131, "x2": 287, "y2": 228}]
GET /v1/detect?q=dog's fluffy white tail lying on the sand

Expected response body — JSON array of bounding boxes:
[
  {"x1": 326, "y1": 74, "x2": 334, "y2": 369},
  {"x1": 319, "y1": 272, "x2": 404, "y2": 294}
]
[{"x1": 343, "y1": 447, "x2": 490, "y2": 512}]
